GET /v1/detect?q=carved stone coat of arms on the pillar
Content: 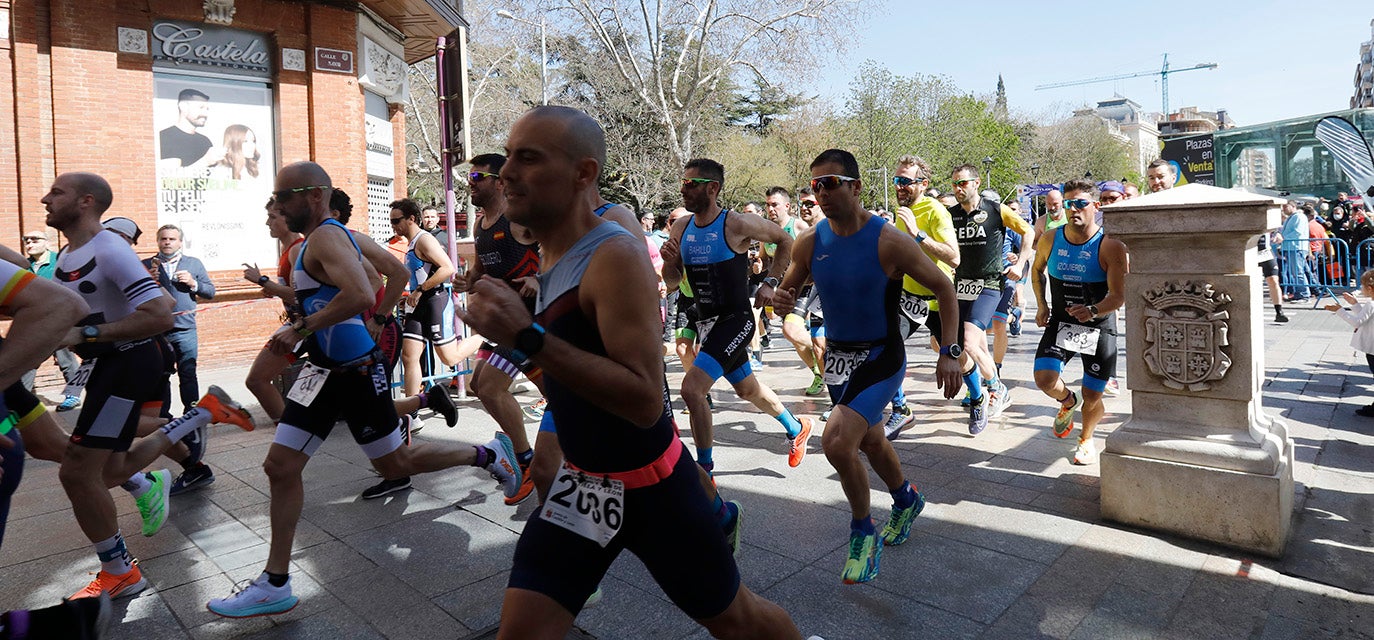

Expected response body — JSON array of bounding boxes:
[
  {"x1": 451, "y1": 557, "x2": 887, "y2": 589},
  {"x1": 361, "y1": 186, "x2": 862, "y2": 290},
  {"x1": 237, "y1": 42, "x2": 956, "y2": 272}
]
[{"x1": 1143, "y1": 280, "x2": 1231, "y2": 391}]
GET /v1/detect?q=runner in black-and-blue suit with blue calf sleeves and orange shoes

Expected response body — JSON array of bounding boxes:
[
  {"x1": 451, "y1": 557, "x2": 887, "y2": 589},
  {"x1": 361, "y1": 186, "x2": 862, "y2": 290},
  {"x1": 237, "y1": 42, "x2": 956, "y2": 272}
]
[{"x1": 662, "y1": 158, "x2": 811, "y2": 472}]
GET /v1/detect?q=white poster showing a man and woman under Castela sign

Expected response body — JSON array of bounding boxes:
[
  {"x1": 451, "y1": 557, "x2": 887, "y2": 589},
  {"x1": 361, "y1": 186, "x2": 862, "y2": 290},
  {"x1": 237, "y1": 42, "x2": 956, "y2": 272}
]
[{"x1": 147, "y1": 73, "x2": 276, "y2": 271}]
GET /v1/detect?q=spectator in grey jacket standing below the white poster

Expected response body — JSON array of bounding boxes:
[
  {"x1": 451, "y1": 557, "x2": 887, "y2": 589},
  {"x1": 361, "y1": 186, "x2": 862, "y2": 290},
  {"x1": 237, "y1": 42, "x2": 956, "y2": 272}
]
[{"x1": 143, "y1": 224, "x2": 214, "y2": 412}]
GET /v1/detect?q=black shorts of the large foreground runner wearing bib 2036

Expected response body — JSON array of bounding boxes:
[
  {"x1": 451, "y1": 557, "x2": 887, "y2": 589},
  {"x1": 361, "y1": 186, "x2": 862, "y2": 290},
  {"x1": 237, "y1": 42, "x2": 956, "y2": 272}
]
[{"x1": 507, "y1": 442, "x2": 739, "y2": 619}]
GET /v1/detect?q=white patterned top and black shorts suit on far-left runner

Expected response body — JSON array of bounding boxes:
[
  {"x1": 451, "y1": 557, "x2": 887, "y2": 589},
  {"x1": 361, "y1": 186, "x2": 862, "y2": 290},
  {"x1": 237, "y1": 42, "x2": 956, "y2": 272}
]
[{"x1": 54, "y1": 231, "x2": 166, "y2": 452}]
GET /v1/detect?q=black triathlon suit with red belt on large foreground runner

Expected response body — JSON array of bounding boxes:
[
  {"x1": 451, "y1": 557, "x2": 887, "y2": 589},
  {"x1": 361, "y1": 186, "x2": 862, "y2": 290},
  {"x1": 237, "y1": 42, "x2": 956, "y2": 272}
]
[{"x1": 508, "y1": 224, "x2": 743, "y2": 619}]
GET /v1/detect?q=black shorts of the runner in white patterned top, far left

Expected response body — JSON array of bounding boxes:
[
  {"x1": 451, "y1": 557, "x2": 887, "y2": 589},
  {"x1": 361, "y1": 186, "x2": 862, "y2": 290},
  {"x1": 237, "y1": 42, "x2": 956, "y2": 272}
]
[{"x1": 71, "y1": 339, "x2": 166, "y2": 452}]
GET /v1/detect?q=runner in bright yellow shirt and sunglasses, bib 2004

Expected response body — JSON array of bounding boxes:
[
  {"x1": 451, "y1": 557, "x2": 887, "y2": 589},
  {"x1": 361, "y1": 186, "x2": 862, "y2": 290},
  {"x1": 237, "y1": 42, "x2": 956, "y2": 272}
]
[{"x1": 882, "y1": 155, "x2": 959, "y2": 439}]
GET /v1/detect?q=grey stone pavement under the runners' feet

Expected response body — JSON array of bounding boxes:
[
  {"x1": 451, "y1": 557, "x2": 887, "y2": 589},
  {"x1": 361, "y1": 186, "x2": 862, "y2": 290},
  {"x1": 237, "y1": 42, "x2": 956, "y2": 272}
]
[{"x1": 0, "y1": 300, "x2": 1374, "y2": 640}]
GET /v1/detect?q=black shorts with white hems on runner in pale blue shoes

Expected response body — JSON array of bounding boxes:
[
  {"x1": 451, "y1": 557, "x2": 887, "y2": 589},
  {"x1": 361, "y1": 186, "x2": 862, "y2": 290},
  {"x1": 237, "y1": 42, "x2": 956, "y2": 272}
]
[{"x1": 272, "y1": 352, "x2": 401, "y2": 460}]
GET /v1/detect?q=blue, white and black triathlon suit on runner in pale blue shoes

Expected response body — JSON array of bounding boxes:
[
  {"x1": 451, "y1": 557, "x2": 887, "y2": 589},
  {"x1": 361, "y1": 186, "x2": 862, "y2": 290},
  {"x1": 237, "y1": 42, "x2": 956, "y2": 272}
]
[{"x1": 272, "y1": 220, "x2": 401, "y2": 460}]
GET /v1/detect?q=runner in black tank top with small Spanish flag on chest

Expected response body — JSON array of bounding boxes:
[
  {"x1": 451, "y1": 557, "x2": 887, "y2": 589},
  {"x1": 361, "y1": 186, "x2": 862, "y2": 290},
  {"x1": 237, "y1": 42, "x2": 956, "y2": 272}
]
[{"x1": 453, "y1": 154, "x2": 541, "y2": 504}]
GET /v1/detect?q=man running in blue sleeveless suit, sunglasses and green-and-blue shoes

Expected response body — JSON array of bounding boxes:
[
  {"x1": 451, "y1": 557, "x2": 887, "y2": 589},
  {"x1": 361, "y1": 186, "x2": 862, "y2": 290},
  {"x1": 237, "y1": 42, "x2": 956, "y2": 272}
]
[{"x1": 774, "y1": 148, "x2": 959, "y2": 584}]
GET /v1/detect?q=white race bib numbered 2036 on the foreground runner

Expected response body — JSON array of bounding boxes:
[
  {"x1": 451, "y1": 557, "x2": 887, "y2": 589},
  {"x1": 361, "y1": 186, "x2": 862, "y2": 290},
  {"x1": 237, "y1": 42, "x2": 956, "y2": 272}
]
[{"x1": 539, "y1": 461, "x2": 625, "y2": 548}]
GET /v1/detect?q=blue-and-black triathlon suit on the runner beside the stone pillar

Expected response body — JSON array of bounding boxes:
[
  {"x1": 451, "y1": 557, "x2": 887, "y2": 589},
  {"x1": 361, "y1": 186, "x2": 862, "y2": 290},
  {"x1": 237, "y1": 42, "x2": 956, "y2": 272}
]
[{"x1": 1035, "y1": 228, "x2": 1116, "y2": 393}]
